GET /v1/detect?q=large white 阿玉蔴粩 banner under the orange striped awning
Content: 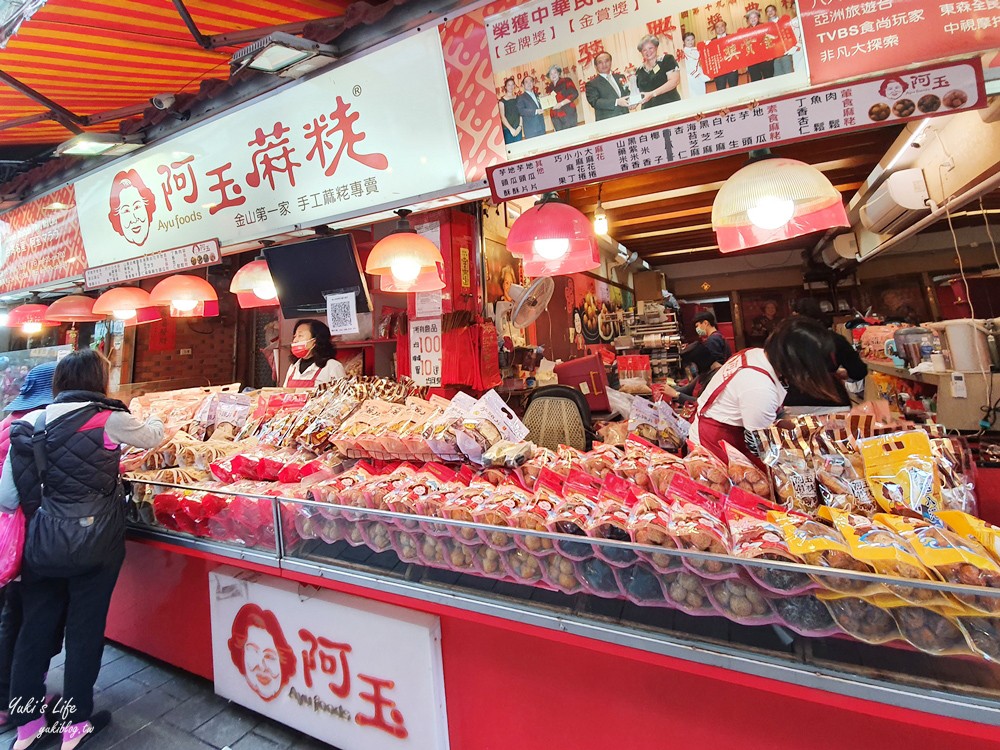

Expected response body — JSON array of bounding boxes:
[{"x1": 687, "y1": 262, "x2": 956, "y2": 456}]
[{"x1": 75, "y1": 29, "x2": 465, "y2": 266}]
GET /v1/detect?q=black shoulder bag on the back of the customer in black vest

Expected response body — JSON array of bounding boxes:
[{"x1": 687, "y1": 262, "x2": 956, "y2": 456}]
[{"x1": 24, "y1": 410, "x2": 126, "y2": 577}]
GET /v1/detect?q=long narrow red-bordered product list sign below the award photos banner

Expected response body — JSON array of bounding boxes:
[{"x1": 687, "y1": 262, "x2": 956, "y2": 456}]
[{"x1": 487, "y1": 58, "x2": 986, "y2": 201}]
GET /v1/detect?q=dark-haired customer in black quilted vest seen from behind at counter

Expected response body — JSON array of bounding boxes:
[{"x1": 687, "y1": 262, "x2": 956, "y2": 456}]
[{"x1": 0, "y1": 349, "x2": 163, "y2": 750}]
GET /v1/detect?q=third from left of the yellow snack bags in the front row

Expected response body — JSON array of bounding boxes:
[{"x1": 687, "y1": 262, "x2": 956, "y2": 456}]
[{"x1": 875, "y1": 513, "x2": 1000, "y2": 615}]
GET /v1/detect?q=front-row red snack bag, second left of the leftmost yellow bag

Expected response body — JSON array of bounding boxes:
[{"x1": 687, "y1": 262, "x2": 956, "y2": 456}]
[{"x1": 667, "y1": 474, "x2": 736, "y2": 578}]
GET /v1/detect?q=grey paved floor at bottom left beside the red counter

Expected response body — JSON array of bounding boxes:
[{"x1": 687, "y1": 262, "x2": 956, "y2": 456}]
[{"x1": 0, "y1": 643, "x2": 335, "y2": 750}]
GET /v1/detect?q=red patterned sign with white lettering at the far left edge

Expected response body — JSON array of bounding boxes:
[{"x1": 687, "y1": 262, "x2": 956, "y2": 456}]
[{"x1": 0, "y1": 185, "x2": 86, "y2": 294}]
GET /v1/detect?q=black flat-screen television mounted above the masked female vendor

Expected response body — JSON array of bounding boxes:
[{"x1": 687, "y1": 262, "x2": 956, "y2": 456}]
[{"x1": 264, "y1": 234, "x2": 372, "y2": 318}]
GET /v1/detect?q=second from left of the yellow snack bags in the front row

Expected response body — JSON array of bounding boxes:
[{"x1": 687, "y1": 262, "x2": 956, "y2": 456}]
[{"x1": 819, "y1": 507, "x2": 954, "y2": 607}]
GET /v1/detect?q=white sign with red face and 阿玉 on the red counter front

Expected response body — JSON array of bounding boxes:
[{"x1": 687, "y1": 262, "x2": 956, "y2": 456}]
[{"x1": 209, "y1": 567, "x2": 448, "y2": 750}]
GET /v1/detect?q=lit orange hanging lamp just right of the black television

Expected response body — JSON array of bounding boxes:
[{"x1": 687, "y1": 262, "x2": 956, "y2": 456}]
[{"x1": 365, "y1": 208, "x2": 444, "y2": 292}]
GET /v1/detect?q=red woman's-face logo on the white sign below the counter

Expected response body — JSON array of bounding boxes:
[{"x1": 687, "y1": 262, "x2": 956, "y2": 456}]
[{"x1": 228, "y1": 604, "x2": 295, "y2": 701}]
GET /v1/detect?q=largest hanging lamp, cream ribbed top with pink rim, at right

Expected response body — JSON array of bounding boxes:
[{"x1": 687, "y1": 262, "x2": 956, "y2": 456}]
[{"x1": 712, "y1": 154, "x2": 850, "y2": 253}]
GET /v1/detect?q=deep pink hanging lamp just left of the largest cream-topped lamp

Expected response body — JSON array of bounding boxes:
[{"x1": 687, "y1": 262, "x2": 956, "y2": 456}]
[{"x1": 507, "y1": 193, "x2": 601, "y2": 278}]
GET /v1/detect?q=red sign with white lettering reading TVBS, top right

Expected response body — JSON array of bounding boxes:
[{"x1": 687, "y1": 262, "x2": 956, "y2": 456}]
[{"x1": 799, "y1": 0, "x2": 1000, "y2": 84}]
